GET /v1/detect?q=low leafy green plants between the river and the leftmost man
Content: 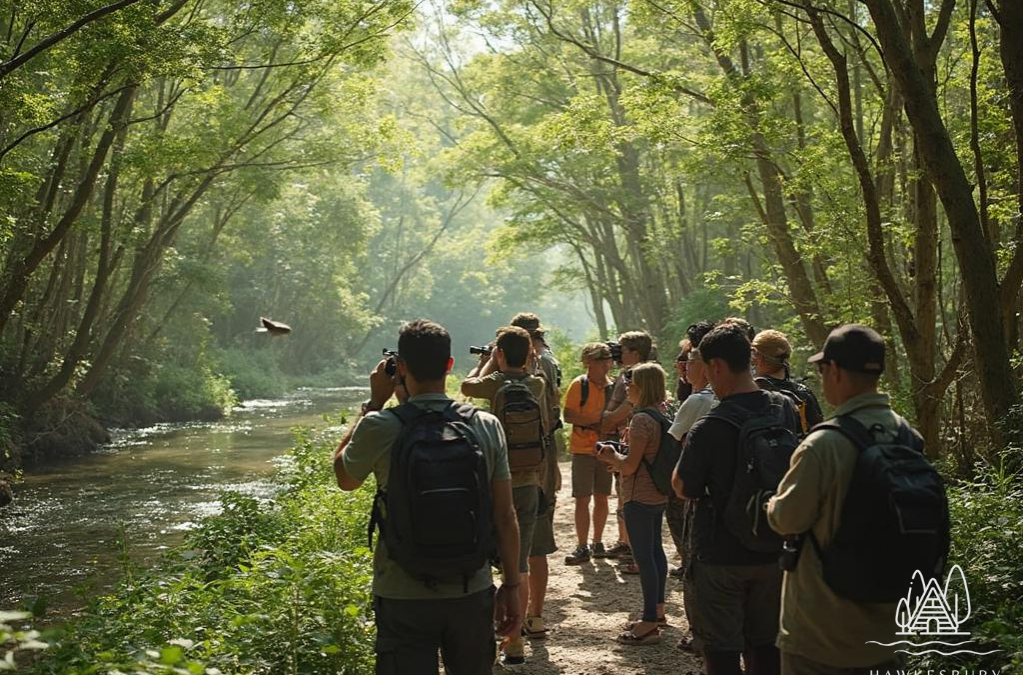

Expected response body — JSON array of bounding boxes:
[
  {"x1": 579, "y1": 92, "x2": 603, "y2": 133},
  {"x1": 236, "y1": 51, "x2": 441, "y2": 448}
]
[{"x1": 26, "y1": 422, "x2": 373, "y2": 675}]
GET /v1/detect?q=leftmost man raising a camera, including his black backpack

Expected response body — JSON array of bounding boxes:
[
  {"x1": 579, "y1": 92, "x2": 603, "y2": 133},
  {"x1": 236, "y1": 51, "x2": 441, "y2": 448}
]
[{"x1": 334, "y1": 320, "x2": 522, "y2": 675}]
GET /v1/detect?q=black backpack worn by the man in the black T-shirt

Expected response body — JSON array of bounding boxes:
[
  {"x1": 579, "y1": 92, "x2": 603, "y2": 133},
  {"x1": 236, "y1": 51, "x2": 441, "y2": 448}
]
[{"x1": 706, "y1": 391, "x2": 800, "y2": 553}]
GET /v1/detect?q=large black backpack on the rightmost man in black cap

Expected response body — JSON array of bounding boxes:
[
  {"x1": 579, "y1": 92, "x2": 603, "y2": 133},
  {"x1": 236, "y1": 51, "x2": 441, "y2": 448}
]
[{"x1": 810, "y1": 416, "x2": 949, "y2": 602}]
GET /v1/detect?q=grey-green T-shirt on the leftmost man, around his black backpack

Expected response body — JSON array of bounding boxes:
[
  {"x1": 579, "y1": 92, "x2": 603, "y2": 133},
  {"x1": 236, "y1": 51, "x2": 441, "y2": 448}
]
[{"x1": 342, "y1": 393, "x2": 510, "y2": 600}]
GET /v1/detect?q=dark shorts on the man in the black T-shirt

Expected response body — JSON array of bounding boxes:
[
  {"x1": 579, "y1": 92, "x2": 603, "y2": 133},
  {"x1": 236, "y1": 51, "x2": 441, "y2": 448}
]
[{"x1": 689, "y1": 560, "x2": 782, "y2": 651}]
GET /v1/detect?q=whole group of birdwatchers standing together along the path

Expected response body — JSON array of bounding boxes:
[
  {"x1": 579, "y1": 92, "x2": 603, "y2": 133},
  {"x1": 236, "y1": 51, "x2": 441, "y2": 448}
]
[{"x1": 334, "y1": 313, "x2": 948, "y2": 675}]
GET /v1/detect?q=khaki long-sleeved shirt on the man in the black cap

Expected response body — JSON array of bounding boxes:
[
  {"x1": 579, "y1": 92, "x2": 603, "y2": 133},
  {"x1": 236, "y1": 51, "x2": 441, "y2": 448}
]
[{"x1": 768, "y1": 393, "x2": 910, "y2": 668}]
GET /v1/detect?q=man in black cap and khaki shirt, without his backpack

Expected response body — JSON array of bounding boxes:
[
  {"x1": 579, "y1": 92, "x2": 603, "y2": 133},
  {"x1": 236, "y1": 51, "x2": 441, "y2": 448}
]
[{"x1": 768, "y1": 324, "x2": 900, "y2": 675}]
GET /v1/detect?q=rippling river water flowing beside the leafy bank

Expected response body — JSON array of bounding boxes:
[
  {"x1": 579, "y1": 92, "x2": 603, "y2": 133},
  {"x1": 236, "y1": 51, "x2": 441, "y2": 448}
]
[{"x1": 0, "y1": 387, "x2": 367, "y2": 617}]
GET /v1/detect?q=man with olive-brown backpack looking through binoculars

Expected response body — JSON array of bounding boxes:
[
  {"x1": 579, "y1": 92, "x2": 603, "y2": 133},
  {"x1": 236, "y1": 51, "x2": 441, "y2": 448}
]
[{"x1": 462, "y1": 326, "x2": 552, "y2": 665}]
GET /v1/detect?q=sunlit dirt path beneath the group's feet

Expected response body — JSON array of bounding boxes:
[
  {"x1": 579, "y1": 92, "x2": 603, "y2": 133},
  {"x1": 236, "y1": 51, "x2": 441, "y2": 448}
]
[{"x1": 494, "y1": 462, "x2": 700, "y2": 675}]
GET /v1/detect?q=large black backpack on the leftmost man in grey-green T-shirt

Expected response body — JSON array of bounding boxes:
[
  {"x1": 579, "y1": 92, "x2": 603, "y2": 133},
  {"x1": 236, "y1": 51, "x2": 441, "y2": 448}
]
[{"x1": 369, "y1": 402, "x2": 495, "y2": 585}]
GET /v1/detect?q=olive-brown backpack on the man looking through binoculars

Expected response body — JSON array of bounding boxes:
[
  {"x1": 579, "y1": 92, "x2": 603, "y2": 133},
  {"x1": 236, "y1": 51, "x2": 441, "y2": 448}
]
[{"x1": 490, "y1": 378, "x2": 544, "y2": 471}]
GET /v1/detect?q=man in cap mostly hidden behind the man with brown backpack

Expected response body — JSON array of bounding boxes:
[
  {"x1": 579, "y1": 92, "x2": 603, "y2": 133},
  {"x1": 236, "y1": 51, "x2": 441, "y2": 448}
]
[{"x1": 509, "y1": 311, "x2": 565, "y2": 639}]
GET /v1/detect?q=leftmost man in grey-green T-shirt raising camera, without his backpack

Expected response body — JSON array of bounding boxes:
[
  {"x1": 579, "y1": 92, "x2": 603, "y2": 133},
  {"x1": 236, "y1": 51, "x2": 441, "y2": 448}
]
[{"x1": 334, "y1": 320, "x2": 522, "y2": 675}]
